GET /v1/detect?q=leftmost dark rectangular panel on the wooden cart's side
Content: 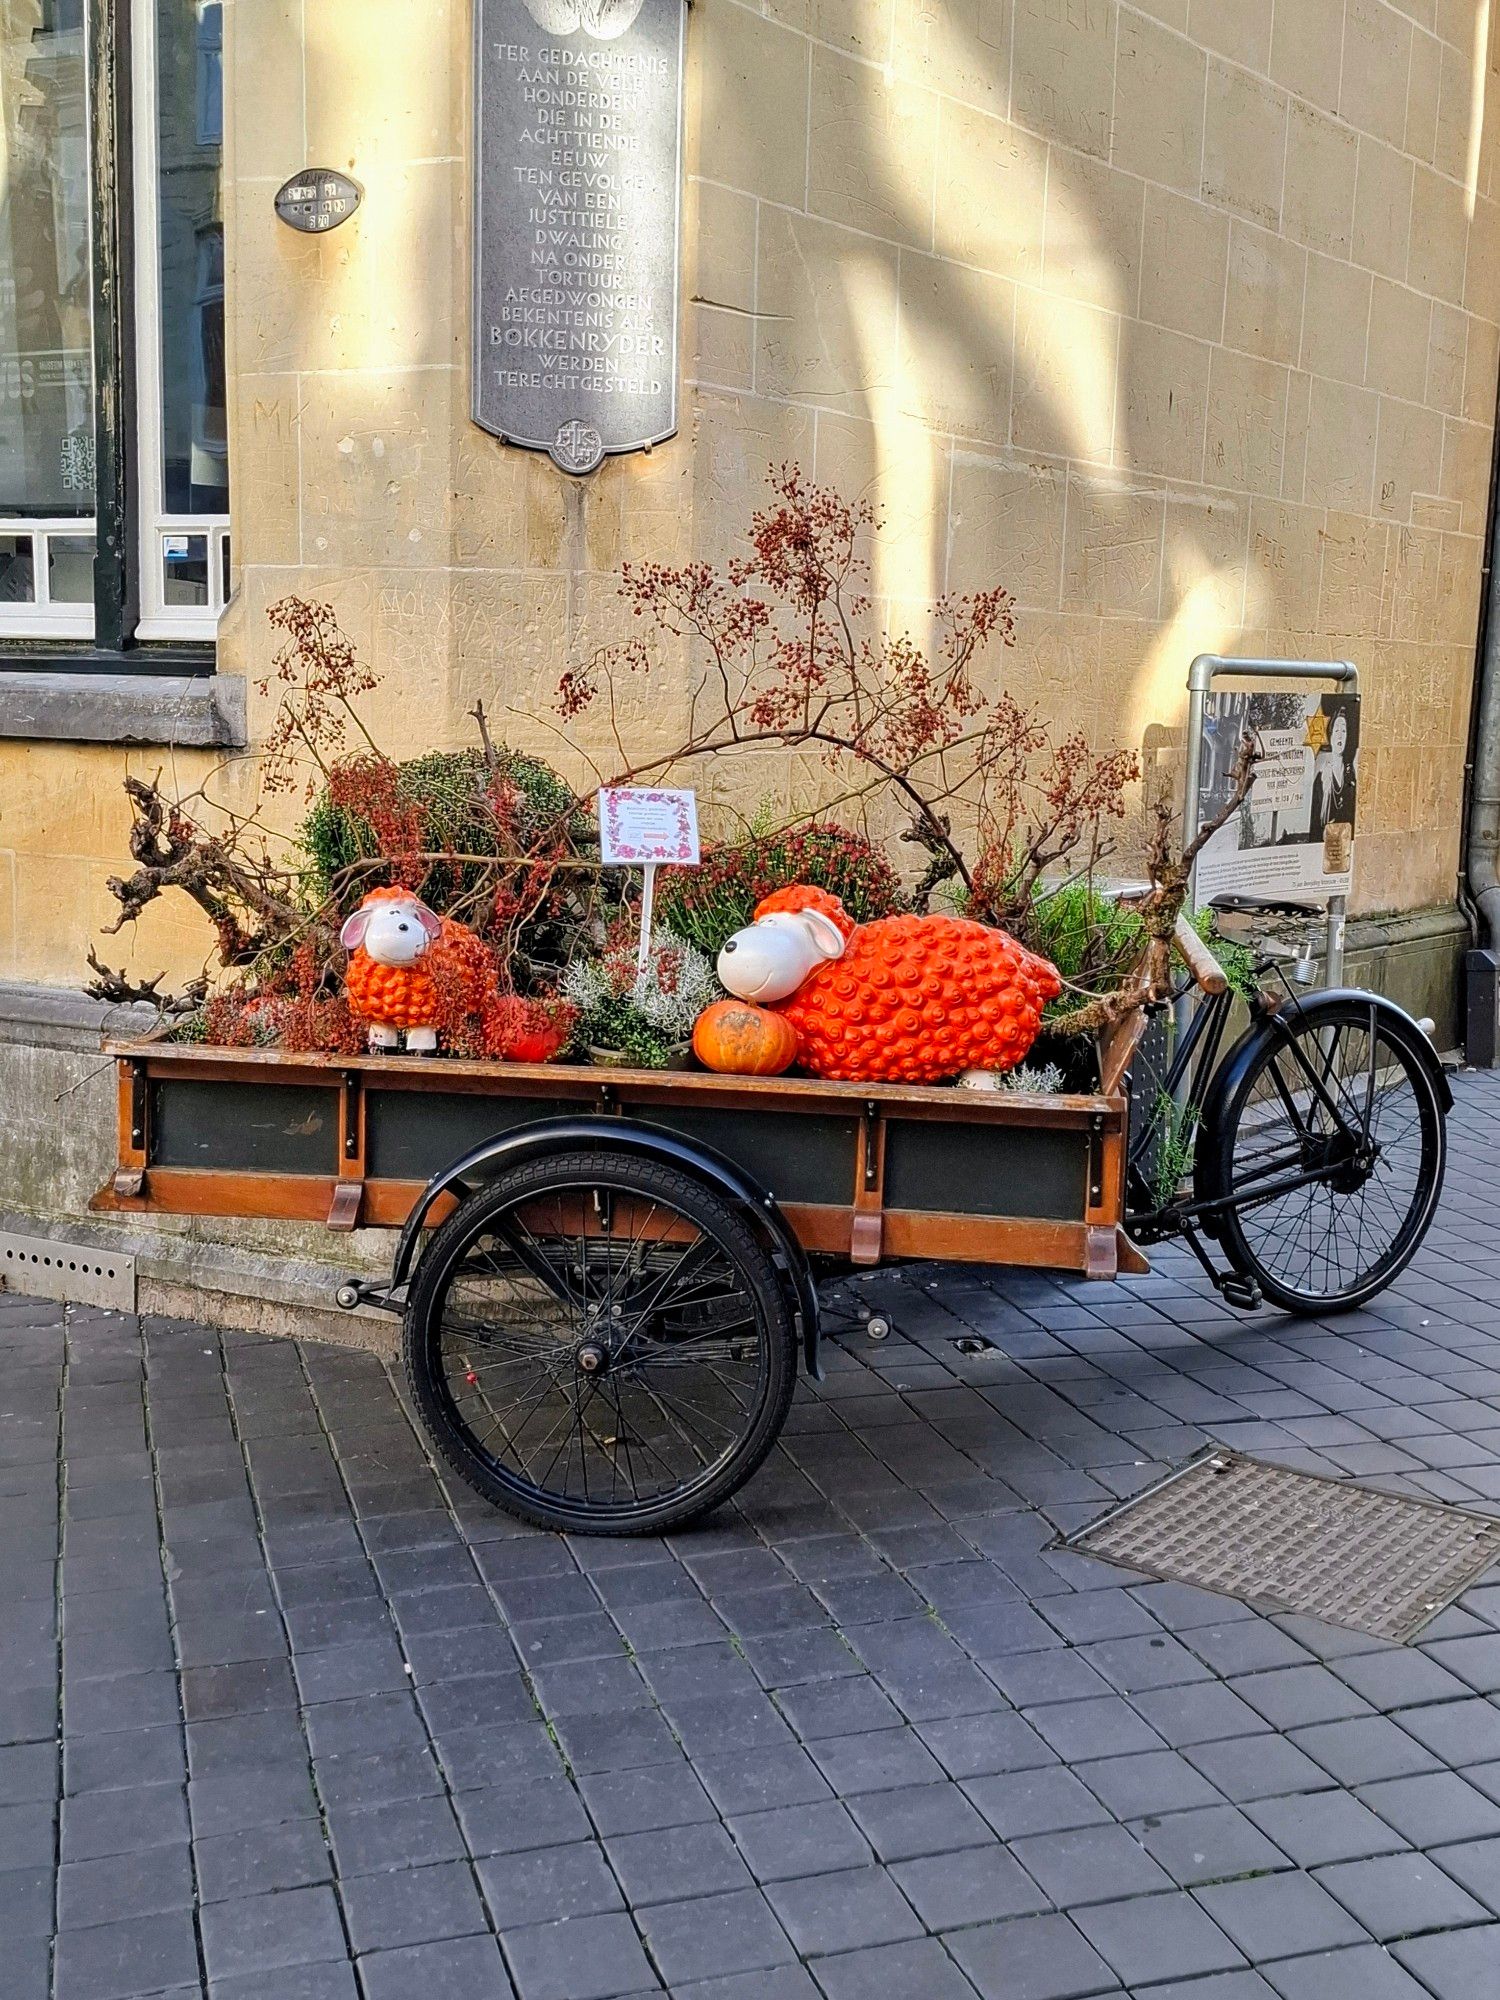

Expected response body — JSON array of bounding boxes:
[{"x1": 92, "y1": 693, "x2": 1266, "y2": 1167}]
[{"x1": 152, "y1": 1078, "x2": 338, "y2": 1174}]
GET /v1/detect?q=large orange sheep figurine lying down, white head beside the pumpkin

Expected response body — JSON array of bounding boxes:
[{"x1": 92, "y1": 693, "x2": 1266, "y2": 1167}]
[{"x1": 718, "y1": 886, "x2": 1062, "y2": 1084}]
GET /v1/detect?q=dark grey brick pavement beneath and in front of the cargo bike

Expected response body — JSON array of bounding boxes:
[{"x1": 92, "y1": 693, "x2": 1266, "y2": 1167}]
[{"x1": 0, "y1": 1078, "x2": 1500, "y2": 2000}]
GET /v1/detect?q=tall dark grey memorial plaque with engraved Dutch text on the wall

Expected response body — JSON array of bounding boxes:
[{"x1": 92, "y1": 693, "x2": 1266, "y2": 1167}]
[{"x1": 474, "y1": 0, "x2": 686, "y2": 474}]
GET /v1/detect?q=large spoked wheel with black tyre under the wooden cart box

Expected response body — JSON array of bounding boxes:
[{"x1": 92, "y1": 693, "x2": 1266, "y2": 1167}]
[{"x1": 404, "y1": 1152, "x2": 796, "y2": 1534}]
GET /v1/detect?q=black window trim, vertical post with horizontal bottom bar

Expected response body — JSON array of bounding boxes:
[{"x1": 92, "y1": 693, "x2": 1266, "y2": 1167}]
[{"x1": 0, "y1": 0, "x2": 216, "y2": 674}]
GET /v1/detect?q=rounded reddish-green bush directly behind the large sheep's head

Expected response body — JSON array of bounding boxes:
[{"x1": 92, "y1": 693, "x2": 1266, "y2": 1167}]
[{"x1": 656, "y1": 820, "x2": 902, "y2": 958}]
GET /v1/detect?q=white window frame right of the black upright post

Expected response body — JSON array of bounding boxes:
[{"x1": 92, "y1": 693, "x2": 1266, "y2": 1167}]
[{"x1": 130, "y1": 0, "x2": 230, "y2": 642}]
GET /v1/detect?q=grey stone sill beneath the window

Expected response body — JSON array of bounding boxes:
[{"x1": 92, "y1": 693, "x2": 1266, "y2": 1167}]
[{"x1": 0, "y1": 668, "x2": 246, "y2": 750}]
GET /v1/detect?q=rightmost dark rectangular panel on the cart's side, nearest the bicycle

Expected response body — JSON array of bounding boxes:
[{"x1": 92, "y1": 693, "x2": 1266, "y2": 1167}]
[{"x1": 886, "y1": 1118, "x2": 1088, "y2": 1222}]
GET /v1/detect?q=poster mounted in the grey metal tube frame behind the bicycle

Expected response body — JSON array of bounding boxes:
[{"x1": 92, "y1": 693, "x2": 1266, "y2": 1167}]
[{"x1": 1198, "y1": 692, "x2": 1360, "y2": 904}]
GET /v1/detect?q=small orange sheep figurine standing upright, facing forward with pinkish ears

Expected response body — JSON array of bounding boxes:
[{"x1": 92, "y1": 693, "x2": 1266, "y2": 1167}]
[{"x1": 340, "y1": 888, "x2": 496, "y2": 1056}]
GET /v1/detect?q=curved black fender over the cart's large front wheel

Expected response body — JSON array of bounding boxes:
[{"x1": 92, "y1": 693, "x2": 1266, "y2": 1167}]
[{"x1": 390, "y1": 1118, "x2": 822, "y2": 1382}]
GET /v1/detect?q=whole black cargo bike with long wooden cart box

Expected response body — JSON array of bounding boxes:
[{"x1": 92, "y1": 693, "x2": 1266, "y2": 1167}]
[{"x1": 94, "y1": 898, "x2": 1452, "y2": 1534}]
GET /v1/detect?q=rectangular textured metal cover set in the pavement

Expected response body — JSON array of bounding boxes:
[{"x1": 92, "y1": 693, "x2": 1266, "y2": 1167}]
[{"x1": 1068, "y1": 1452, "x2": 1500, "y2": 1640}]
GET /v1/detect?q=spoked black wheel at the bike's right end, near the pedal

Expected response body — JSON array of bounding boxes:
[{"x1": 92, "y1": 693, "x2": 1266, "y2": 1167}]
[{"x1": 1200, "y1": 996, "x2": 1446, "y2": 1314}]
